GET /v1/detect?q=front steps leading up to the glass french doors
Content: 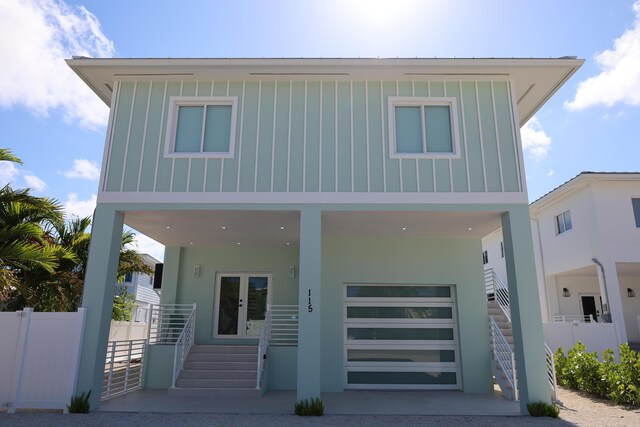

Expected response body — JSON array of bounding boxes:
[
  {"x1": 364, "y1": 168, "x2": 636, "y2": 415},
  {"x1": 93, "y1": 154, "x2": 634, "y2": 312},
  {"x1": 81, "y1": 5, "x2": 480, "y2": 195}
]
[{"x1": 169, "y1": 345, "x2": 260, "y2": 397}]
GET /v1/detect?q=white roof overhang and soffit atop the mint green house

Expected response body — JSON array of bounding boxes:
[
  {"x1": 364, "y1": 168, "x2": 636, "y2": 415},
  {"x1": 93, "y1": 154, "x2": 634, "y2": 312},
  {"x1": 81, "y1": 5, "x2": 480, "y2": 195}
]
[{"x1": 67, "y1": 57, "x2": 584, "y2": 125}]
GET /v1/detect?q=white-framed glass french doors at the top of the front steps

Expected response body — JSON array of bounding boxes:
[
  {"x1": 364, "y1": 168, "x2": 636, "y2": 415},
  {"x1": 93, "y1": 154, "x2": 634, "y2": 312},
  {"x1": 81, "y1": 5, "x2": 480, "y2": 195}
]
[{"x1": 213, "y1": 273, "x2": 271, "y2": 338}]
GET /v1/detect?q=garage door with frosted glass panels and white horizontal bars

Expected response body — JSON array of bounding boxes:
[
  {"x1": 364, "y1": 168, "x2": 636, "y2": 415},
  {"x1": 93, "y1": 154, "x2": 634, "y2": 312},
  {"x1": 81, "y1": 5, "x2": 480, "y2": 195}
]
[{"x1": 344, "y1": 284, "x2": 460, "y2": 389}]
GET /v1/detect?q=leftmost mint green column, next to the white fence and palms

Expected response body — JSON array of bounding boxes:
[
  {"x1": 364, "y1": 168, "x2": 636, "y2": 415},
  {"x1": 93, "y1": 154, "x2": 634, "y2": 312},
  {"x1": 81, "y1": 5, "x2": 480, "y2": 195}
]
[{"x1": 76, "y1": 205, "x2": 124, "y2": 410}]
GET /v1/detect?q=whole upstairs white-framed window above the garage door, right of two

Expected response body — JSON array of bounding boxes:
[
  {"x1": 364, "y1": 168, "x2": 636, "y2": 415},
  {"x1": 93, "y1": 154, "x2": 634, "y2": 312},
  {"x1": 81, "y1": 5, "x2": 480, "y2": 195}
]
[{"x1": 389, "y1": 96, "x2": 460, "y2": 159}]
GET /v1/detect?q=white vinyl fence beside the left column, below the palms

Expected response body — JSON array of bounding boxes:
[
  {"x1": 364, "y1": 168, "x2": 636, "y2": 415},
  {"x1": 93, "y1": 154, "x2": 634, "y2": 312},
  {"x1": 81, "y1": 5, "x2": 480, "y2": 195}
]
[{"x1": 0, "y1": 308, "x2": 85, "y2": 412}]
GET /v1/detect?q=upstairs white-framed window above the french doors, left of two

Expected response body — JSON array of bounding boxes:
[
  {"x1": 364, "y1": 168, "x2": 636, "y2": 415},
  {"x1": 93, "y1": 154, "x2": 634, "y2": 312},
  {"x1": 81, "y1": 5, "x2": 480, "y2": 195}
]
[{"x1": 165, "y1": 96, "x2": 238, "y2": 158}]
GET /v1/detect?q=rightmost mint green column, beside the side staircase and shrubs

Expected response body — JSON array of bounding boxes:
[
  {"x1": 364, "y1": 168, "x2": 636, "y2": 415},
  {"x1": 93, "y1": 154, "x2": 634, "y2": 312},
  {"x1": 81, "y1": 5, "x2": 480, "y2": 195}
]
[{"x1": 502, "y1": 205, "x2": 551, "y2": 414}]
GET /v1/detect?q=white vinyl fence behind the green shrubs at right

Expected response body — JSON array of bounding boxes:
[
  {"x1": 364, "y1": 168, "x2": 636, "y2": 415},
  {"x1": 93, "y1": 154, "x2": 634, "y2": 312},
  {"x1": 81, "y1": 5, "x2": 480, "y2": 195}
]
[{"x1": 543, "y1": 322, "x2": 622, "y2": 359}]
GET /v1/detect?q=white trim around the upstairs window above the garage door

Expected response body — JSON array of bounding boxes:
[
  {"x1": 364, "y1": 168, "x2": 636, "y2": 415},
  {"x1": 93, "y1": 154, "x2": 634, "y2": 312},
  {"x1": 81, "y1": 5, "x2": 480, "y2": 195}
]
[{"x1": 388, "y1": 96, "x2": 461, "y2": 159}]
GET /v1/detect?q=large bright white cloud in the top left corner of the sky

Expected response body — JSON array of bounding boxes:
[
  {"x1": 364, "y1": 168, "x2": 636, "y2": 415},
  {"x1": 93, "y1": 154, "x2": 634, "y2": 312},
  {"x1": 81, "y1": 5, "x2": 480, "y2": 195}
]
[{"x1": 0, "y1": 0, "x2": 115, "y2": 128}]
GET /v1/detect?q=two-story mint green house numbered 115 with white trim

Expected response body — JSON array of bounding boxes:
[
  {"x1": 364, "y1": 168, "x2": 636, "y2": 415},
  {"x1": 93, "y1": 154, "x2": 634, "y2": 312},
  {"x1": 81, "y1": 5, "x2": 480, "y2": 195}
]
[{"x1": 68, "y1": 57, "x2": 582, "y2": 408}]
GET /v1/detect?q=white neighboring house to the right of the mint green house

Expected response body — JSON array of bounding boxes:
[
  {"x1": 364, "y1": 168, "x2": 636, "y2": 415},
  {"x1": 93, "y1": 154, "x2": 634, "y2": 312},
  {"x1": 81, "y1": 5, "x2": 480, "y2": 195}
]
[{"x1": 483, "y1": 172, "x2": 640, "y2": 343}]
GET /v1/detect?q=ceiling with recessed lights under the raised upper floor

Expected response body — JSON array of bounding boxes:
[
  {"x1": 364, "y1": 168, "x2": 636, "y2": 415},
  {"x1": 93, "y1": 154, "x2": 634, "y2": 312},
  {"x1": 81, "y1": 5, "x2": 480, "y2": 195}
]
[{"x1": 125, "y1": 210, "x2": 501, "y2": 247}]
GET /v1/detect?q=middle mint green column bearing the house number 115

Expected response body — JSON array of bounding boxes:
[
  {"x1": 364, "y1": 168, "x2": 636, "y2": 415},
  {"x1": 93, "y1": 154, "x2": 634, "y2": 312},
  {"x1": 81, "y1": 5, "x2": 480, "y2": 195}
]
[{"x1": 297, "y1": 207, "x2": 322, "y2": 400}]
